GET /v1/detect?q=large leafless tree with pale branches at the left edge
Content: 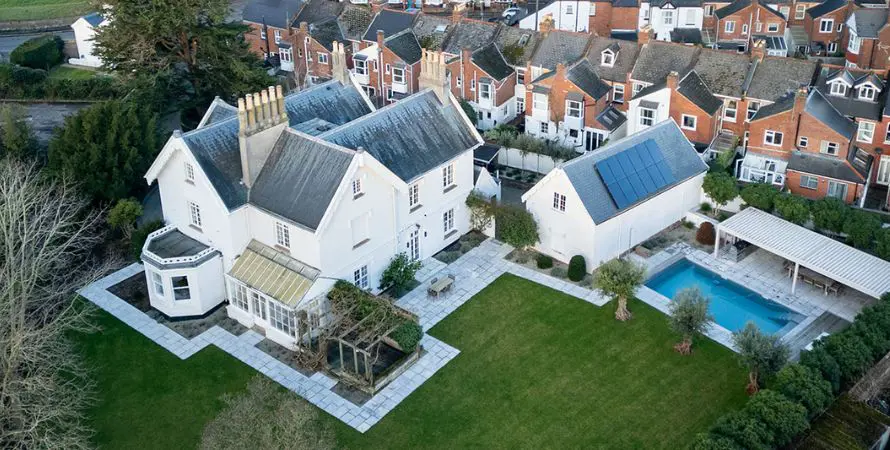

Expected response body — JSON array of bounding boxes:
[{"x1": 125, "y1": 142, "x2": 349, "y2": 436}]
[{"x1": 0, "y1": 158, "x2": 114, "y2": 449}]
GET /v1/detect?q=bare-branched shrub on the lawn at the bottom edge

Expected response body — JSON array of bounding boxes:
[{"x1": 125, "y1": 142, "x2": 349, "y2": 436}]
[{"x1": 201, "y1": 375, "x2": 334, "y2": 450}]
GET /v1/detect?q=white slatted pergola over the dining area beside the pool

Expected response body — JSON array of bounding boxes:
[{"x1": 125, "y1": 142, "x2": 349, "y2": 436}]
[{"x1": 714, "y1": 208, "x2": 890, "y2": 298}]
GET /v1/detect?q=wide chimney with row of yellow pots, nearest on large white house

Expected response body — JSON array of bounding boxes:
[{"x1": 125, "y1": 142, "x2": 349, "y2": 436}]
[{"x1": 238, "y1": 86, "x2": 288, "y2": 188}]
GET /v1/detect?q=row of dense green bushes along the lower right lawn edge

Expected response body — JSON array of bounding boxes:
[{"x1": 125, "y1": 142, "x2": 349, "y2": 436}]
[{"x1": 692, "y1": 293, "x2": 890, "y2": 449}]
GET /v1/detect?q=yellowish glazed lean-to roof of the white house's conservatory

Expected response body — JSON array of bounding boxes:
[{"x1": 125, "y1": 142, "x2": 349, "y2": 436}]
[{"x1": 229, "y1": 240, "x2": 319, "y2": 307}]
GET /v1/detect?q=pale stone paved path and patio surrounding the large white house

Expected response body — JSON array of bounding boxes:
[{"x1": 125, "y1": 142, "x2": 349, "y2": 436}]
[{"x1": 78, "y1": 239, "x2": 606, "y2": 433}]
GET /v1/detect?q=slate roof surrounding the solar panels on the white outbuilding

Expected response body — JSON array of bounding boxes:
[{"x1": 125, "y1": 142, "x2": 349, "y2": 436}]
[{"x1": 562, "y1": 120, "x2": 708, "y2": 224}]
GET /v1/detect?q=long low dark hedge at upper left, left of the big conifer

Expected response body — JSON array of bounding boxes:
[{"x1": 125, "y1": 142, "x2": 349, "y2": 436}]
[{"x1": 0, "y1": 64, "x2": 127, "y2": 100}]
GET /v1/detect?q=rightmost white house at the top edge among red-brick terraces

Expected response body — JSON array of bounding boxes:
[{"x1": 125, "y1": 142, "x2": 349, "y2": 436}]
[{"x1": 639, "y1": 0, "x2": 705, "y2": 43}]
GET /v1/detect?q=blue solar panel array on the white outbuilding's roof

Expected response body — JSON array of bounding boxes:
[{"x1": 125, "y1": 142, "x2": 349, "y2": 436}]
[{"x1": 594, "y1": 139, "x2": 676, "y2": 209}]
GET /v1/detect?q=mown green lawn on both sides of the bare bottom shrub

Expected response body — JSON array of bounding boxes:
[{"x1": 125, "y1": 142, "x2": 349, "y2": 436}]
[{"x1": 76, "y1": 275, "x2": 746, "y2": 448}]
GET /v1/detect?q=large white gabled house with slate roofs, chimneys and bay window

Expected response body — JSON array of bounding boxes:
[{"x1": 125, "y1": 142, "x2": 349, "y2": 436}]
[{"x1": 142, "y1": 47, "x2": 482, "y2": 347}]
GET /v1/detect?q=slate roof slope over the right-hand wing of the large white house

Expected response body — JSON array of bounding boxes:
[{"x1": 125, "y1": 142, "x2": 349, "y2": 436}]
[{"x1": 319, "y1": 90, "x2": 482, "y2": 182}]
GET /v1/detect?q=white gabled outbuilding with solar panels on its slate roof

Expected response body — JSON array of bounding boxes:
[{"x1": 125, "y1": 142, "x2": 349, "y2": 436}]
[{"x1": 522, "y1": 120, "x2": 708, "y2": 271}]
